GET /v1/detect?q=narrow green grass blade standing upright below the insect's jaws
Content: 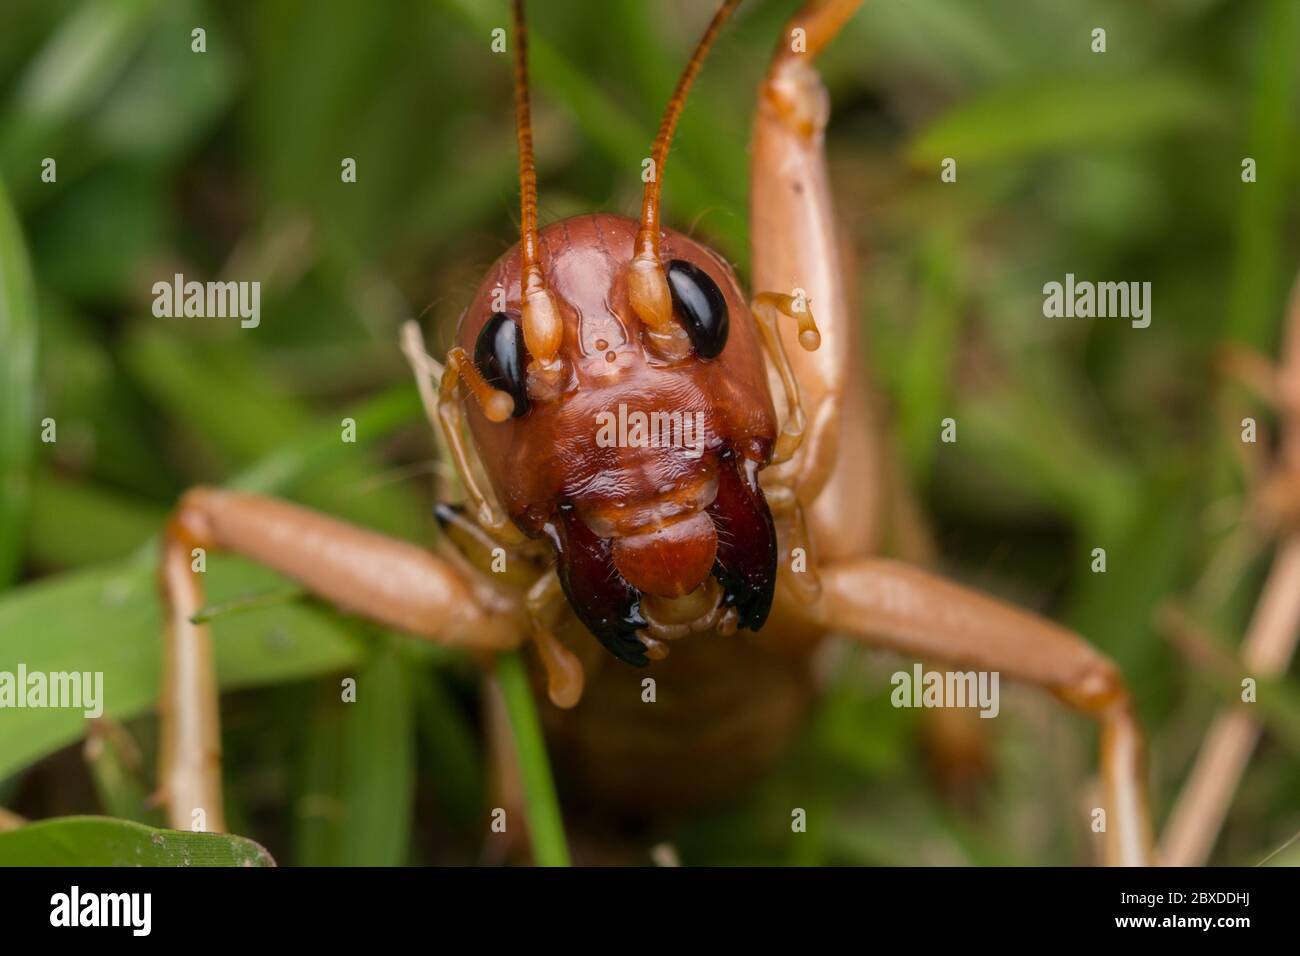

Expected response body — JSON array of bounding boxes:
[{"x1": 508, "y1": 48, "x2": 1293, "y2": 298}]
[{"x1": 497, "y1": 650, "x2": 569, "y2": 866}]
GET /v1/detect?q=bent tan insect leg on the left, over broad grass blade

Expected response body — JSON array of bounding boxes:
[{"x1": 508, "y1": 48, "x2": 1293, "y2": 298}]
[{"x1": 159, "y1": 488, "x2": 527, "y2": 830}]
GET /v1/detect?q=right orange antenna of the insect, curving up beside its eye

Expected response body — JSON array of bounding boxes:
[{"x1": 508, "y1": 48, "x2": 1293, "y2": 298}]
[{"x1": 628, "y1": 0, "x2": 740, "y2": 359}]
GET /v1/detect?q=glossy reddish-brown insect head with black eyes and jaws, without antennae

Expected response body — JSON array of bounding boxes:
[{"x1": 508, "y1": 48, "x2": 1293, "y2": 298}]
[{"x1": 458, "y1": 215, "x2": 777, "y2": 663}]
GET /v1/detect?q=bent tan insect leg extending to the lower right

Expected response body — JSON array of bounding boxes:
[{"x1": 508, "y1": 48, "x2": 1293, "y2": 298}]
[{"x1": 807, "y1": 558, "x2": 1152, "y2": 865}]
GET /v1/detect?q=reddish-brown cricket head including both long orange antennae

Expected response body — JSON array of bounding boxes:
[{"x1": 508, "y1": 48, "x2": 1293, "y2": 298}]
[{"x1": 447, "y1": 0, "x2": 776, "y2": 665}]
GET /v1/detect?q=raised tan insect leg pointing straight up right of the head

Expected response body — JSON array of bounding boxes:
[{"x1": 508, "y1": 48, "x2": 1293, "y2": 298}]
[{"x1": 750, "y1": 0, "x2": 880, "y2": 561}]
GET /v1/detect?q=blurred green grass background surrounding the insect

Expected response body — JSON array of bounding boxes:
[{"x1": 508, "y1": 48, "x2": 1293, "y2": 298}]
[{"x1": 0, "y1": 0, "x2": 1300, "y2": 864}]
